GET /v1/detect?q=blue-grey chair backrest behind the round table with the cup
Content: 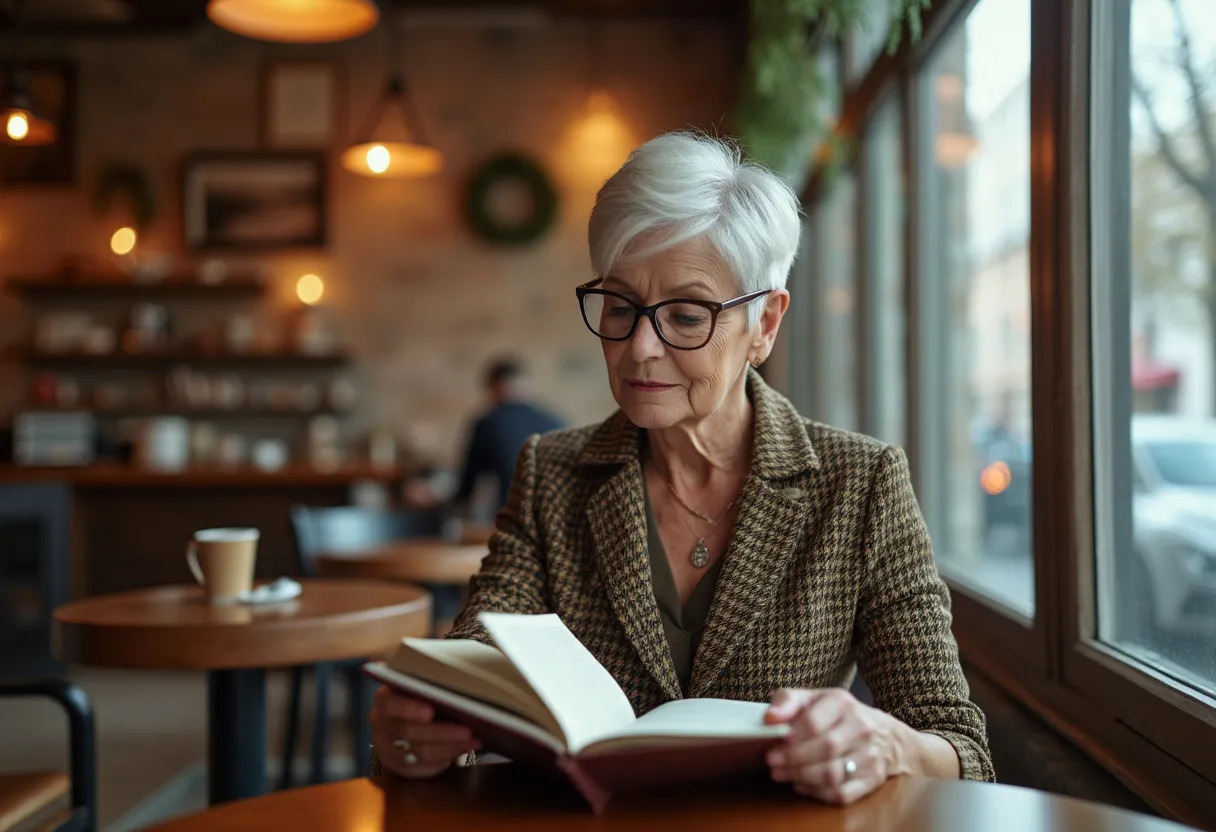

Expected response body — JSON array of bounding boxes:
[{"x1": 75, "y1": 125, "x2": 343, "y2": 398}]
[{"x1": 292, "y1": 506, "x2": 444, "y2": 578}]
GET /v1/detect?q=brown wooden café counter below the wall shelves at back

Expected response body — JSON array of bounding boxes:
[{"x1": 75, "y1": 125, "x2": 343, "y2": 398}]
[{"x1": 0, "y1": 465, "x2": 404, "y2": 597}]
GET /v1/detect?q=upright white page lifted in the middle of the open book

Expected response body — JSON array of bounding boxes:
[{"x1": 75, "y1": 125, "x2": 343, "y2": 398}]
[{"x1": 478, "y1": 612, "x2": 635, "y2": 753}]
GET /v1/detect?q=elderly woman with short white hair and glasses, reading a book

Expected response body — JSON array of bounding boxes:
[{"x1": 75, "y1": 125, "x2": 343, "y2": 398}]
[{"x1": 372, "y1": 133, "x2": 992, "y2": 803}]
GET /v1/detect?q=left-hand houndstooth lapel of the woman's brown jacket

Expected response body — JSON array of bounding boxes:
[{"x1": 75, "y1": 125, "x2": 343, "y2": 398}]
[{"x1": 581, "y1": 414, "x2": 681, "y2": 699}]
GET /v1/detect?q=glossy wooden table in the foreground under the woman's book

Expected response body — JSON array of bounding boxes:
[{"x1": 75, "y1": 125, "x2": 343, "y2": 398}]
[{"x1": 142, "y1": 765, "x2": 1186, "y2": 832}]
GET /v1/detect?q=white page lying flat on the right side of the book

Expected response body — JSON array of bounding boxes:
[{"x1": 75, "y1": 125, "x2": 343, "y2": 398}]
[{"x1": 589, "y1": 699, "x2": 789, "y2": 753}]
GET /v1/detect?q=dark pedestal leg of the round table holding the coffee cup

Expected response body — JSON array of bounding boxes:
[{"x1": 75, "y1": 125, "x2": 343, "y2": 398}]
[{"x1": 207, "y1": 669, "x2": 266, "y2": 805}]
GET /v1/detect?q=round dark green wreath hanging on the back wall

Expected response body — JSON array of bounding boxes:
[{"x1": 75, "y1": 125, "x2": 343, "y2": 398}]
[{"x1": 465, "y1": 153, "x2": 557, "y2": 246}]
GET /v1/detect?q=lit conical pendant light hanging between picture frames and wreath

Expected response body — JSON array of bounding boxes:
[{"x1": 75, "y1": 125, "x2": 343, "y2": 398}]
[{"x1": 342, "y1": 21, "x2": 444, "y2": 179}]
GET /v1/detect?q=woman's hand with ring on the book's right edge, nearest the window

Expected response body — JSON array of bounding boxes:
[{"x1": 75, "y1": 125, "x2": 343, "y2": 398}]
[{"x1": 765, "y1": 687, "x2": 912, "y2": 804}]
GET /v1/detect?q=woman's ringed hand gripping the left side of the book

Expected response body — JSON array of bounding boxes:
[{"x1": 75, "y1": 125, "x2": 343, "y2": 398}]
[{"x1": 371, "y1": 687, "x2": 482, "y2": 778}]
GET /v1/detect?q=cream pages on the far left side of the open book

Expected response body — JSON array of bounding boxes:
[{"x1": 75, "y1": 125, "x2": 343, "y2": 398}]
[{"x1": 388, "y1": 639, "x2": 565, "y2": 742}]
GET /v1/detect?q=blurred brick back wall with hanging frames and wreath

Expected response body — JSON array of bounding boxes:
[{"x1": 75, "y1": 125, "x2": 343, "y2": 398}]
[{"x1": 0, "y1": 21, "x2": 738, "y2": 459}]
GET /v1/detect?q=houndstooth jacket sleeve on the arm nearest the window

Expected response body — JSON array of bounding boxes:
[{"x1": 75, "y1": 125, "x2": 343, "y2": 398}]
[{"x1": 855, "y1": 448, "x2": 995, "y2": 781}]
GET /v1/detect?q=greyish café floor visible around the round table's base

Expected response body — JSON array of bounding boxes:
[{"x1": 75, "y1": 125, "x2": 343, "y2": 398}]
[{"x1": 0, "y1": 668, "x2": 350, "y2": 830}]
